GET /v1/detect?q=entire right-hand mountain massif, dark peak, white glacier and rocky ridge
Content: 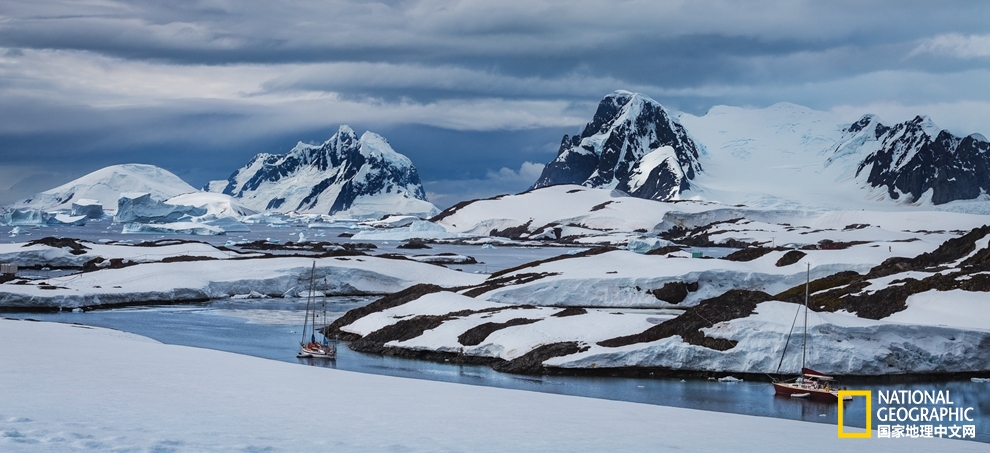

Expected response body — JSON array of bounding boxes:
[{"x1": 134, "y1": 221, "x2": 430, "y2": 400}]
[{"x1": 533, "y1": 91, "x2": 990, "y2": 210}]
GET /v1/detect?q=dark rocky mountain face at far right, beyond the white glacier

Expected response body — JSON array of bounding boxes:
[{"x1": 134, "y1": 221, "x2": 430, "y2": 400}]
[{"x1": 847, "y1": 116, "x2": 990, "y2": 204}]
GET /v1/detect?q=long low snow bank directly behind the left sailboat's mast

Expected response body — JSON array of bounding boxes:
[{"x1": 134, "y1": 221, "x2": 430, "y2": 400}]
[{"x1": 0, "y1": 256, "x2": 484, "y2": 308}]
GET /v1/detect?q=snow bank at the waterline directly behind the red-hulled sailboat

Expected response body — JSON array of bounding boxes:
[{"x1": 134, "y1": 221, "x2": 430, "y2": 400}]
[{"x1": 545, "y1": 295, "x2": 990, "y2": 375}]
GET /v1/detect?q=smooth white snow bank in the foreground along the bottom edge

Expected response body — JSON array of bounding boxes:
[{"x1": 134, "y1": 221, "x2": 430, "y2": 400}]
[{"x1": 0, "y1": 320, "x2": 986, "y2": 453}]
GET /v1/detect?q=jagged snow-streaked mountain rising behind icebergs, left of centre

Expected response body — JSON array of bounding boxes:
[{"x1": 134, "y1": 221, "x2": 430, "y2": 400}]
[{"x1": 210, "y1": 126, "x2": 439, "y2": 217}]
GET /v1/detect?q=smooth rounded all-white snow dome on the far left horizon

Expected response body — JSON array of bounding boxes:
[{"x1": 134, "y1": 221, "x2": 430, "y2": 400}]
[{"x1": 12, "y1": 164, "x2": 196, "y2": 211}]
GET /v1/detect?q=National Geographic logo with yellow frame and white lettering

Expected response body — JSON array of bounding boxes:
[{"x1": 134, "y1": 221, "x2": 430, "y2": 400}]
[{"x1": 838, "y1": 390, "x2": 976, "y2": 439}]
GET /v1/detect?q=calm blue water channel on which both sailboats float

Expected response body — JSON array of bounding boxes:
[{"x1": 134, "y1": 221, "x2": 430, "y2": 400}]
[{"x1": 4, "y1": 297, "x2": 990, "y2": 442}]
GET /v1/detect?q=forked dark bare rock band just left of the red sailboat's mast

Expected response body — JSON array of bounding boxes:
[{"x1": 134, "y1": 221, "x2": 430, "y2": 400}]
[{"x1": 598, "y1": 289, "x2": 773, "y2": 351}]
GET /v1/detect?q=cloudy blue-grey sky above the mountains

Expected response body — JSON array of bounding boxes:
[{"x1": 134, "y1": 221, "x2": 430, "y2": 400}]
[{"x1": 0, "y1": 0, "x2": 990, "y2": 207}]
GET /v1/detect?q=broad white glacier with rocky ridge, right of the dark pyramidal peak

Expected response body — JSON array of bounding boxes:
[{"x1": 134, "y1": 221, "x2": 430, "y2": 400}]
[{"x1": 677, "y1": 103, "x2": 990, "y2": 208}]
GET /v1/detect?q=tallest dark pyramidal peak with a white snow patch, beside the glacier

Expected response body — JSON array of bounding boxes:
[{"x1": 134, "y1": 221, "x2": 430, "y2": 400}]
[{"x1": 533, "y1": 91, "x2": 701, "y2": 200}]
